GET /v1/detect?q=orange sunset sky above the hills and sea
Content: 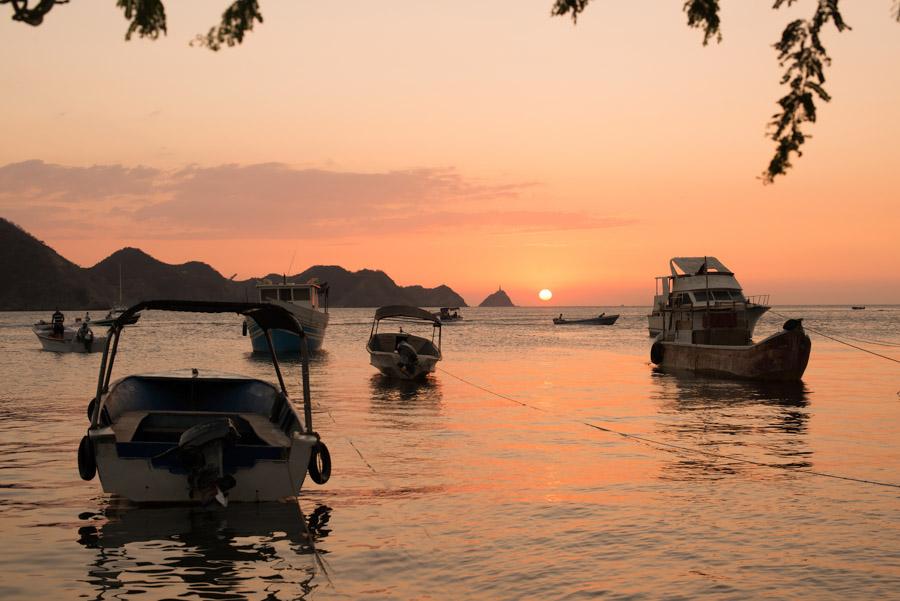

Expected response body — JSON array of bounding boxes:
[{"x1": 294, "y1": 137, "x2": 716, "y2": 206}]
[{"x1": 0, "y1": 0, "x2": 900, "y2": 305}]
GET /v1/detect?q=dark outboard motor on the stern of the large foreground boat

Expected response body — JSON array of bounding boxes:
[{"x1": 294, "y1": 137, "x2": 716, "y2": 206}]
[{"x1": 178, "y1": 417, "x2": 240, "y2": 507}]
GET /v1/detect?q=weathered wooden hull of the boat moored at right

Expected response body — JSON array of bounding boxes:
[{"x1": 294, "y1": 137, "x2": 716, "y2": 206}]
[{"x1": 650, "y1": 326, "x2": 812, "y2": 381}]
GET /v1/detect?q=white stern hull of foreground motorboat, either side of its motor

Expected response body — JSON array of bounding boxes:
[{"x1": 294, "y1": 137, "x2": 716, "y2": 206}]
[{"x1": 90, "y1": 428, "x2": 316, "y2": 504}]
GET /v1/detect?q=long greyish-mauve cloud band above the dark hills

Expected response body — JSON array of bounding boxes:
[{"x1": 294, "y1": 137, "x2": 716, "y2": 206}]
[{"x1": 0, "y1": 160, "x2": 630, "y2": 239}]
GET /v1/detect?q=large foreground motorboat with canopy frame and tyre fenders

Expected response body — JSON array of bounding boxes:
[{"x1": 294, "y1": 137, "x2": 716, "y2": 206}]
[{"x1": 78, "y1": 301, "x2": 331, "y2": 505}]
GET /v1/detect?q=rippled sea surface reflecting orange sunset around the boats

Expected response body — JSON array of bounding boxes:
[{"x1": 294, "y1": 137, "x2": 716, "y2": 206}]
[{"x1": 0, "y1": 307, "x2": 900, "y2": 599}]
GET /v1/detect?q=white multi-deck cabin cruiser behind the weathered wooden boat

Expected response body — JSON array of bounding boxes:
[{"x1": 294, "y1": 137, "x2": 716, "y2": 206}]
[{"x1": 647, "y1": 257, "x2": 771, "y2": 336}]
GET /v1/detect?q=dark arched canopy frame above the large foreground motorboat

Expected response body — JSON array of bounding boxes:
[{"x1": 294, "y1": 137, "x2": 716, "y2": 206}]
[{"x1": 90, "y1": 300, "x2": 315, "y2": 434}]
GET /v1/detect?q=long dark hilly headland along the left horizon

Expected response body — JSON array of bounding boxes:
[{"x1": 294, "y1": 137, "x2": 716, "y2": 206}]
[{"x1": 0, "y1": 218, "x2": 468, "y2": 311}]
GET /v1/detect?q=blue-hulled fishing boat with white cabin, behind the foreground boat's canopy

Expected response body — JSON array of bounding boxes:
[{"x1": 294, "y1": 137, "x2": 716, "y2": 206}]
[{"x1": 244, "y1": 278, "x2": 328, "y2": 353}]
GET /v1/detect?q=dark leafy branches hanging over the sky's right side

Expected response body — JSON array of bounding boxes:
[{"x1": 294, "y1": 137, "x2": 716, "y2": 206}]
[{"x1": 551, "y1": 0, "x2": 900, "y2": 183}]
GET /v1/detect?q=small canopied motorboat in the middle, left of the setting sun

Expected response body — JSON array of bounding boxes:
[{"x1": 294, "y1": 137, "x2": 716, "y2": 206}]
[{"x1": 366, "y1": 305, "x2": 442, "y2": 380}]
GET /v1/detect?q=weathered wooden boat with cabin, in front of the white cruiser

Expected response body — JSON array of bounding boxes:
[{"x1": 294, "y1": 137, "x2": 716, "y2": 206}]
[{"x1": 650, "y1": 257, "x2": 812, "y2": 381}]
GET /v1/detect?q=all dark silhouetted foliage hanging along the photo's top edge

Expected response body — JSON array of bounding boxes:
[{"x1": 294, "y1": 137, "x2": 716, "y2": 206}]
[{"x1": 0, "y1": 0, "x2": 900, "y2": 183}]
